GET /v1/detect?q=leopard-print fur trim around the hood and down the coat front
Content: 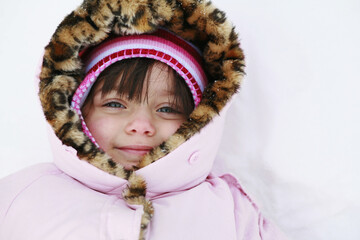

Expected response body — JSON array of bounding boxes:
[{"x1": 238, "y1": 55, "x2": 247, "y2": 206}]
[{"x1": 39, "y1": 0, "x2": 244, "y2": 238}]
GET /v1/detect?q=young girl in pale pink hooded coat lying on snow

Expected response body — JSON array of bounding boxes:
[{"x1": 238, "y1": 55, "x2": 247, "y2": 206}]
[{"x1": 0, "y1": 0, "x2": 285, "y2": 240}]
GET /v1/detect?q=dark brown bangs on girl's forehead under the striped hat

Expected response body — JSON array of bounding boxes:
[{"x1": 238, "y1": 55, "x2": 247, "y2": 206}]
[{"x1": 83, "y1": 58, "x2": 194, "y2": 116}]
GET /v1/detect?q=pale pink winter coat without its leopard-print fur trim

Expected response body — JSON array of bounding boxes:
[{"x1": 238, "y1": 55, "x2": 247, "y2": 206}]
[{"x1": 0, "y1": 105, "x2": 285, "y2": 240}]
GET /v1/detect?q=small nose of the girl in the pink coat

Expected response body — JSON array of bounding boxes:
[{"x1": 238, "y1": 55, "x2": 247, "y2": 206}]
[{"x1": 125, "y1": 112, "x2": 156, "y2": 137}]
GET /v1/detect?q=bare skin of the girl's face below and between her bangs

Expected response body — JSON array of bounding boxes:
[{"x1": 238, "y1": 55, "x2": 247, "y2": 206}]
[{"x1": 83, "y1": 63, "x2": 186, "y2": 169}]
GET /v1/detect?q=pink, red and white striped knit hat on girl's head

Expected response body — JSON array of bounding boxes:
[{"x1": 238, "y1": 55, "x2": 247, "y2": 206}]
[{"x1": 71, "y1": 29, "x2": 207, "y2": 146}]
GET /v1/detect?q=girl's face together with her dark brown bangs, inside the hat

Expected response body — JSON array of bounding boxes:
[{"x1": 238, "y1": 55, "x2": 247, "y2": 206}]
[{"x1": 79, "y1": 58, "x2": 194, "y2": 169}]
